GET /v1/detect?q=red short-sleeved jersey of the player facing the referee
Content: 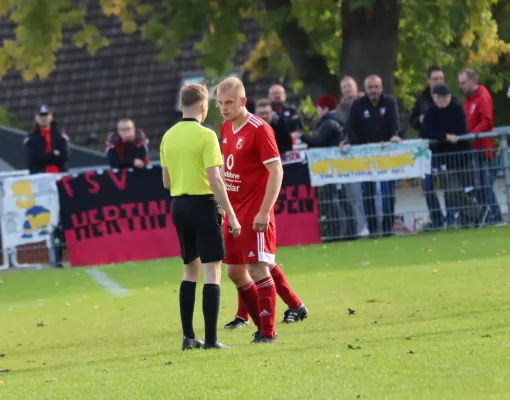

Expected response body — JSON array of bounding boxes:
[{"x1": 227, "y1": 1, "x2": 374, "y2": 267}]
[{"x1": 221, "y1": 114, "x2": 280, "y2": 221}]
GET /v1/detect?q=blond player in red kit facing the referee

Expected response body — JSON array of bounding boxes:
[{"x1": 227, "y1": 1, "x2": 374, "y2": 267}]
[{"x1": 215, "y1": 78, "x2": 307, "y2": 343}]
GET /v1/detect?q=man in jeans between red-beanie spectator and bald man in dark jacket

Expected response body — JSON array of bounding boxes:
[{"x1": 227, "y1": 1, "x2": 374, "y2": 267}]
[{"x1": 337, "y1": 76, "x2": 369, "y2": 236}]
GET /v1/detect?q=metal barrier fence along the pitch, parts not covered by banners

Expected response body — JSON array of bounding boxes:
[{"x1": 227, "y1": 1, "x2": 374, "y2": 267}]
[{"x1": 0, "y1": 128, "x2": 510, "y2": 269}]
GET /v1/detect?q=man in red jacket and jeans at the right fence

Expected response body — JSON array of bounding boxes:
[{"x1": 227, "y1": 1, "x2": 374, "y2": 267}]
[{"x1": 459, "y1": 69, "x2": 503, "y2": 223}]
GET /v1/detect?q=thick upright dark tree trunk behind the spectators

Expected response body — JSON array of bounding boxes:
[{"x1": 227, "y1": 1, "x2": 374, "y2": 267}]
[{"x1": 340, "y1": 0, "x2": 400, "y2": 94}]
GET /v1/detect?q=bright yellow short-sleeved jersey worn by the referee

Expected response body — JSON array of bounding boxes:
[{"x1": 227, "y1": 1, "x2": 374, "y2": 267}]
[{"x1": 159, "y1": 118, "x2": 223, "y2": 197}]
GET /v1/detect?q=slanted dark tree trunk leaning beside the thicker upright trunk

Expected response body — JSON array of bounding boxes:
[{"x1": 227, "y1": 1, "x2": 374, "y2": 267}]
[{"x1": 264, "y1": 0, "x2": 338, "y2": 100}]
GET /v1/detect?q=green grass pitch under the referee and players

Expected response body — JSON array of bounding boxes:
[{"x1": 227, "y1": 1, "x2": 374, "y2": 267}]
[{"x1": 0, "y1": 228, "x2": 510, "y2": 400}]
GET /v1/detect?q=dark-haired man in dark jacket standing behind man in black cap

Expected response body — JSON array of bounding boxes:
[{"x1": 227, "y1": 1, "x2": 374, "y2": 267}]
[{"x1": 411, "y1": 66, "x2": 454, "y2": 230}]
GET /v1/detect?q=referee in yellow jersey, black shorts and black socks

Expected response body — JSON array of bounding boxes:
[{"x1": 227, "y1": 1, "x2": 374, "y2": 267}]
[{"x1": 160, "y1": 84, "x2": 241, "y2": 350}]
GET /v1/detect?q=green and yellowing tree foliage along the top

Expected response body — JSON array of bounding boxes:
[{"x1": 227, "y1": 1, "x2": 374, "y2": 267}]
[{"x1": 0, "y1": 0, "x2": 510, "y2": 105}]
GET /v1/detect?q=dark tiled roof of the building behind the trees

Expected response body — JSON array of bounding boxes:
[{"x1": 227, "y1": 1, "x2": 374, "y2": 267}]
[{"x1": 0, "y1": 4, "x2": 286, "y2": 150}]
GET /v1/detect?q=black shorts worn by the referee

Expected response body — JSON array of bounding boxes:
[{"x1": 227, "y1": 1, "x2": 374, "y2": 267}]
[{"x1": 172, "y1": 195, "x2": 225, "y2": 264}]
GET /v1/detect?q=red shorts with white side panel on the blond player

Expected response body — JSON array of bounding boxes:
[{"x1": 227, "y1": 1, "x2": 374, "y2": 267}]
[{"x1": 223, "y1": 219, "x2": 276, "y2": 265}]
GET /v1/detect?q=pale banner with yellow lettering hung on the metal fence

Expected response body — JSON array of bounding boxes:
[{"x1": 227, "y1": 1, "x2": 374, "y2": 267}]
[{"x1": 306, "y1": 139, "x2": 431, "y2": 186}]
